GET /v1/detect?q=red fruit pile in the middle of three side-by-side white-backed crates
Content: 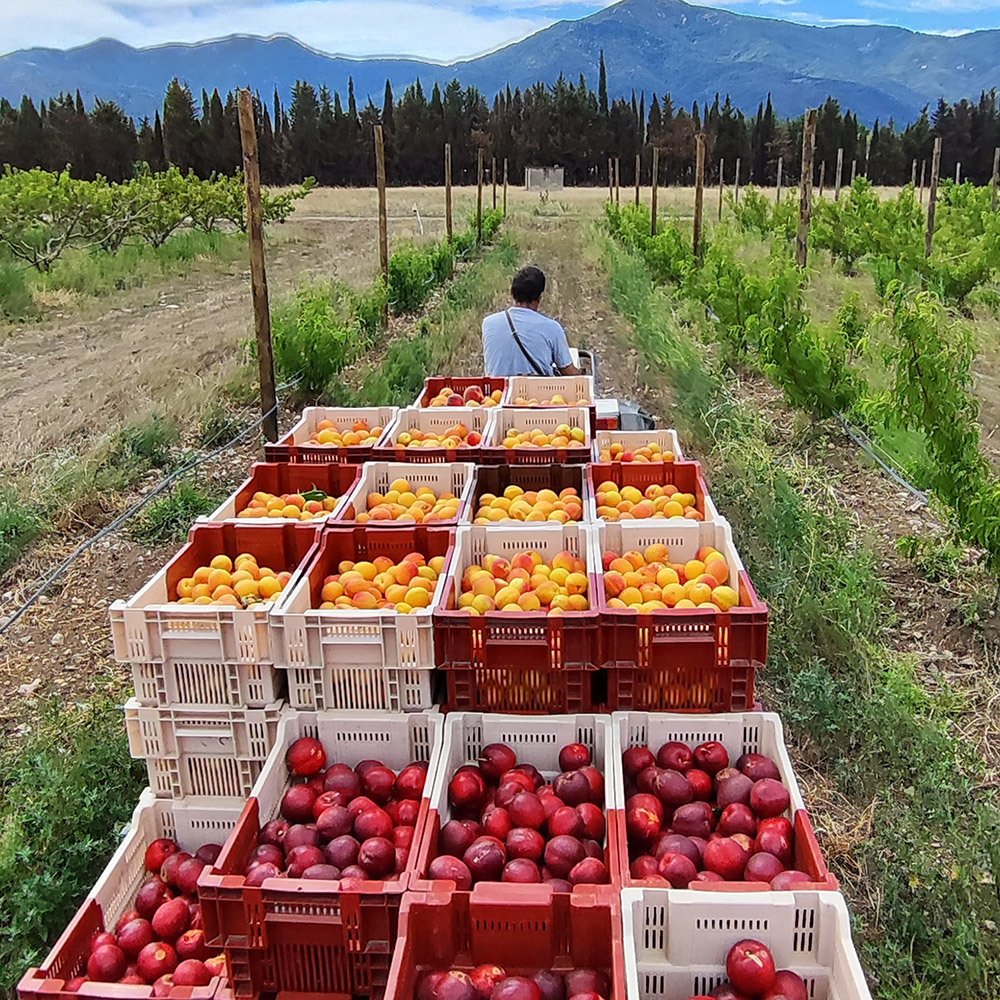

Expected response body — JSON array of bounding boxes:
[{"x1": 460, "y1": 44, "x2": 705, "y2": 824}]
[{"x1": 428, "y1": 743, "x2": 611, "y2": 888}]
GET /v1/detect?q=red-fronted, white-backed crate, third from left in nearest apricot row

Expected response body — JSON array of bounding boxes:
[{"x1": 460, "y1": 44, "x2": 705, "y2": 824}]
[{"x1": 434, "y1": 522, "x2": 606, "y2": 714}]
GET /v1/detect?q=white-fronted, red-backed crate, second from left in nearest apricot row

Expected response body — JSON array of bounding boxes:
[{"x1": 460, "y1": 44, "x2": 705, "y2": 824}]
[{"x1": 271, "y1": 524, "x2": 453, "y2": 712}]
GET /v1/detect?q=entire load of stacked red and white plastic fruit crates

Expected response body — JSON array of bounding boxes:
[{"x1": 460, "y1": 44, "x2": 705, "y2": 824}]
[{"x1": 19, "y1": 376, "x2": 870, "y2": 1000}]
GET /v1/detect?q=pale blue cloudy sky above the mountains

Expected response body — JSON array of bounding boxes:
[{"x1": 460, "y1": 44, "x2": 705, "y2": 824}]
[{"x1": 0, "y1": 0, "x2": 1000, "y2": 60}]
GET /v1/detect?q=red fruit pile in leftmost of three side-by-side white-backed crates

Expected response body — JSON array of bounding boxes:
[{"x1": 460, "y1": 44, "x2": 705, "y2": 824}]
[{"x1": 246, "y1": 736, "x2": 427, "y2": 889}]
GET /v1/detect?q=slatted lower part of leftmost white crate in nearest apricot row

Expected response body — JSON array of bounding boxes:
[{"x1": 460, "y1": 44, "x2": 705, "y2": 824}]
[{"x1": 131, "y1": 660, "x2": 285, "y2": 708}]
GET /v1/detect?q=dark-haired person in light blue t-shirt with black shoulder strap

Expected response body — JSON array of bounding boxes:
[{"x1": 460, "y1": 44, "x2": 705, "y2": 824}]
[{"x1": 483, "y1": 267, "x2": 582, "y2": 376}]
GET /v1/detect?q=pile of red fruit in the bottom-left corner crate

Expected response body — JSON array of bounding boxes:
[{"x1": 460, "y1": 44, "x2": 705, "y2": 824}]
[{"x1": 66, "y1": 838, "x2": 226, "y2": 997}]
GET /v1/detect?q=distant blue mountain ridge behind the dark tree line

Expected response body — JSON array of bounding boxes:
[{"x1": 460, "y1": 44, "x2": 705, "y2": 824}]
[{"x1": 0, "y1": 0, "x2": 1000, "y2": 124}]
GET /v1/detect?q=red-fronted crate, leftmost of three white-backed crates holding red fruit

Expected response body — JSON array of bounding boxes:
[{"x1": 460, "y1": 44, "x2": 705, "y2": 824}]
[{"x1": 198, "y1": 712, "x2": 443, "y2": 996}]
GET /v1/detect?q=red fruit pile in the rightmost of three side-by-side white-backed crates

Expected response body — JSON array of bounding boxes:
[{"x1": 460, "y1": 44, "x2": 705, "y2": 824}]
[{"x1": 622, "y1": 740, "x2": 810, "y2": 889}]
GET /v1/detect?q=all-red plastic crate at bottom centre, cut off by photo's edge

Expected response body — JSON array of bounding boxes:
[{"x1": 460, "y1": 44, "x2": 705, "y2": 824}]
[{"x1": 385, "y1": 883, "x2": 625, "y2": 1000}]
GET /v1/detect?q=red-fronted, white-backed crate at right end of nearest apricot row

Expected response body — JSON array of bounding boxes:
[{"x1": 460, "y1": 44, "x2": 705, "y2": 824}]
[{"x1": 597, "y1": 518, "x2": 768, "y2": 712}]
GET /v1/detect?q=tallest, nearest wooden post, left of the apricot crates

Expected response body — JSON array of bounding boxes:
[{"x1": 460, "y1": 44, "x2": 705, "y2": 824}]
[{"x1": 239, "y1": 89, "x2": 278, "y2": 441}]
